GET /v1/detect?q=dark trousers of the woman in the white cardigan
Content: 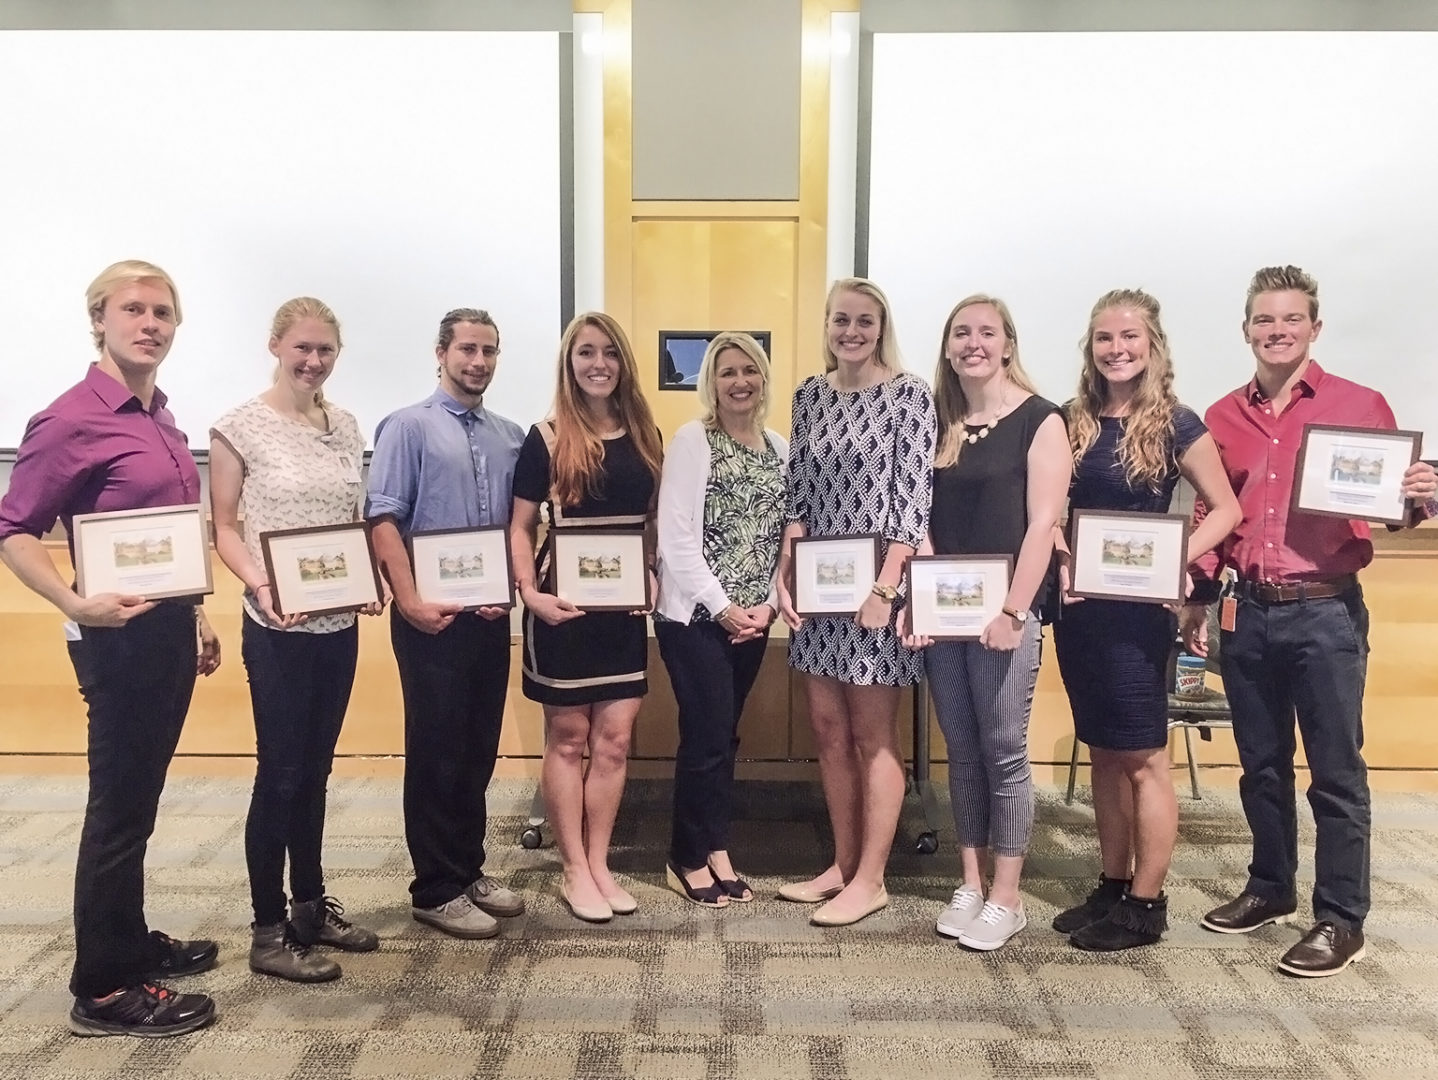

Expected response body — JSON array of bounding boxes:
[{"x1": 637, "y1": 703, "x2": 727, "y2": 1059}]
[{"x1": 654, "y1": 621, "x2": 768, "y2": 870}]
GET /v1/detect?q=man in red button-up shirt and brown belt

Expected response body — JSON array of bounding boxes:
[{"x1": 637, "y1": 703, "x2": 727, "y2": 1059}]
[{"x1": 1181, "y1": 266, "x2": 1438, "y2": 976}]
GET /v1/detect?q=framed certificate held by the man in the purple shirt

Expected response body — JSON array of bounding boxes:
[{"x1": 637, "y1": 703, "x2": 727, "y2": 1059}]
[{"x1": 70, "y1": 505, "x2": 214, "y2": 600}]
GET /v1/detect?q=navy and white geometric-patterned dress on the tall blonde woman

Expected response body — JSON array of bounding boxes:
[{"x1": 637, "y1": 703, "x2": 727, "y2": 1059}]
[{"x1": 787, "y1": 372, "x2": 935, "y2": 686}]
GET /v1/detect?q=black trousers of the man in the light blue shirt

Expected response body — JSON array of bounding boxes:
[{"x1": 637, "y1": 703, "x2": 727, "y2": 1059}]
[{"x1": 390, "y1": 610, "x2": 509, "y2": 907}]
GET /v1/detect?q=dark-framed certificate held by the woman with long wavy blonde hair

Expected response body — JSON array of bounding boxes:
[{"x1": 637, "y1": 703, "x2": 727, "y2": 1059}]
[{"x1": 1070, "y1": 511, "x2": 1188, "y2": 604}]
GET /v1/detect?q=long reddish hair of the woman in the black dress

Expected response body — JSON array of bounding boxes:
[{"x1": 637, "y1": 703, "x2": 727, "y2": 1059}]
[{"x1": 549, "y1": 311, "x2": 664, "y2": 506}]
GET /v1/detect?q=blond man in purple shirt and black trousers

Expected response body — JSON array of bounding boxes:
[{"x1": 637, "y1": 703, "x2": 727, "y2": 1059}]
[{"x1": 0, "y1": 262, "x2": 220, "y2": 1035}]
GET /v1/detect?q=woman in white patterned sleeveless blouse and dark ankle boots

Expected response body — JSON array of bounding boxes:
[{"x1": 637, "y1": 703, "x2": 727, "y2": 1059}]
[{"x1": 210, "y1": 296, "x2": 380, "y2": 982}]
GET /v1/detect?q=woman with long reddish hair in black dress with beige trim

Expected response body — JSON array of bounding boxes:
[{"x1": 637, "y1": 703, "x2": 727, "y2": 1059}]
[{"x1": 509, "y1": 312, "x2": 663, "y2": 922}]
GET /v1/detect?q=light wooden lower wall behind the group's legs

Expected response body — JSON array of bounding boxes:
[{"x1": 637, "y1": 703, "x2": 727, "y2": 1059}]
[{"x1": 0, "y1": 548, "x2": 1438, "y2": 775}]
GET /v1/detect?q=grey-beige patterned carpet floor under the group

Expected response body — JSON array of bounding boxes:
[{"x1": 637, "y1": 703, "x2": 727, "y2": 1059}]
[{"x1": 0, "y1": 777, "x2": 1438, "y2": 1080}]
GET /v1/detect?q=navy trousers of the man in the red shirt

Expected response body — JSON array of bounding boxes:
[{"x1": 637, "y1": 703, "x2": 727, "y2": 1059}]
[{"x1": 1222, "y1": 585, "x2": 1370, "y2": 929}]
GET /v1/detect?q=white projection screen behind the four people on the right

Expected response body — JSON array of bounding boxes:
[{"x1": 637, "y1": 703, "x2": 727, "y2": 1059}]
[{"x1": 869, "y1": 33, "x2": 1438, "y2": 457}]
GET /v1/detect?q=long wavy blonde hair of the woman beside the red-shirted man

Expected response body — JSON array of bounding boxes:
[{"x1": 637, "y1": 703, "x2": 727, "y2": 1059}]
[{"x1": 1067, "y1": 289, "x2": 1178, "y2": 492}]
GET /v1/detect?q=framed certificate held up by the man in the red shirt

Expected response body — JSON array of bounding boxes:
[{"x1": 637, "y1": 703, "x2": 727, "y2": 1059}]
[{"x1": 1290, "y1": 424, "x2": 1424, "y2": 525}]
